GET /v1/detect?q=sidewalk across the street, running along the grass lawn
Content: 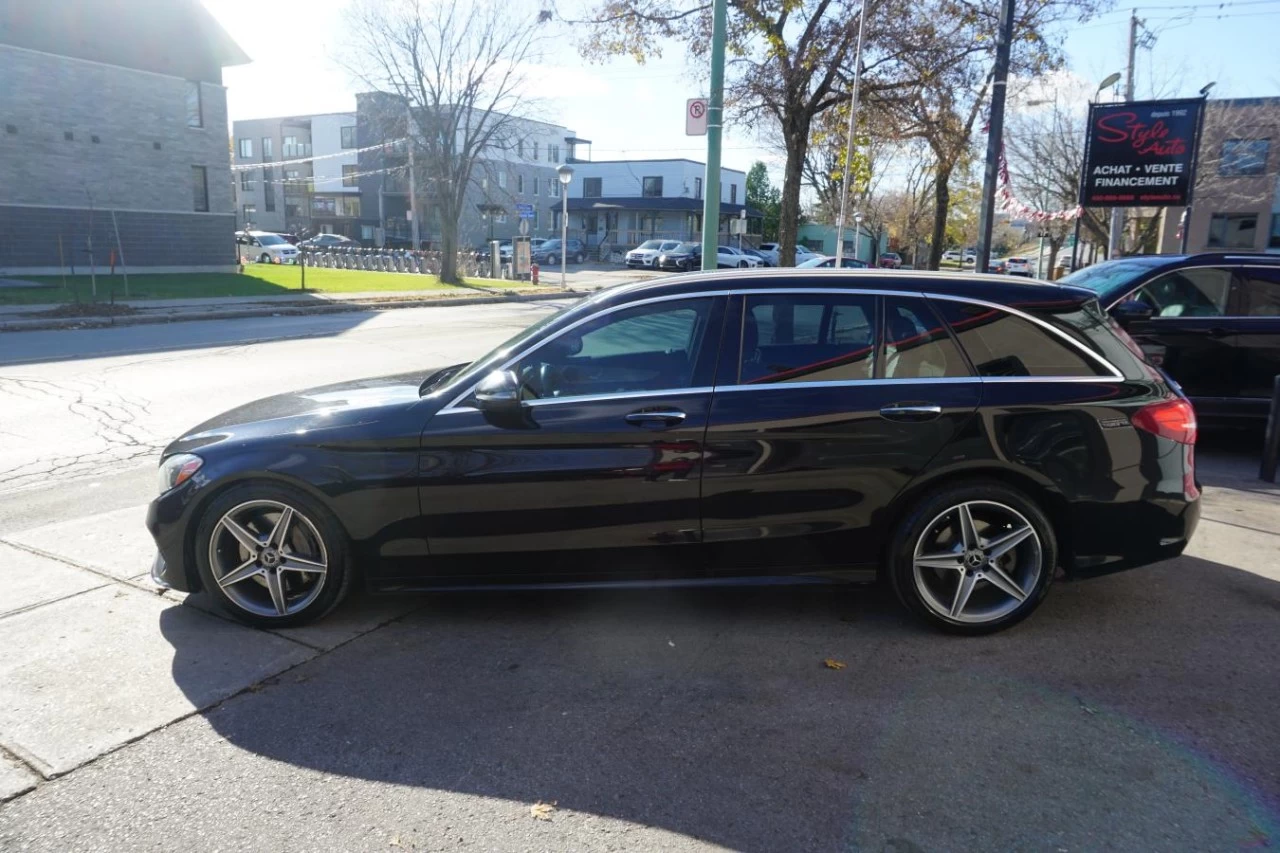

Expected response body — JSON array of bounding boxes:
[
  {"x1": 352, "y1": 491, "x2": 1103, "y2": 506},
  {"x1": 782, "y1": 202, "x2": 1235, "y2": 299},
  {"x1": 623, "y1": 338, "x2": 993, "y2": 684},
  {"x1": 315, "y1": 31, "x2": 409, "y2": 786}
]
[{"x1": 0, "y1": 268, "x2": 653, "y2": 332}]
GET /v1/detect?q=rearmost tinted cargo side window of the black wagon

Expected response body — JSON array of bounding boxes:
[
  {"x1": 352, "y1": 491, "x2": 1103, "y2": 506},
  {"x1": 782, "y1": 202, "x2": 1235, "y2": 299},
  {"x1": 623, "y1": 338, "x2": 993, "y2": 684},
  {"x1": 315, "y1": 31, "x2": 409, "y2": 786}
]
[{"x1": 933, "y1": 300, "x2": 1108, "y2": 377}]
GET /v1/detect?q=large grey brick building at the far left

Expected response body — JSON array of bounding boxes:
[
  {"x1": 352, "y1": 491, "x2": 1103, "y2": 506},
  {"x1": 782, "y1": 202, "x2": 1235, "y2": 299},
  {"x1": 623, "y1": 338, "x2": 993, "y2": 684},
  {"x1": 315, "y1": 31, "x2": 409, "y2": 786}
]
[{"x1": 0, "y1": 0, "x2": 248, "y2": 275}]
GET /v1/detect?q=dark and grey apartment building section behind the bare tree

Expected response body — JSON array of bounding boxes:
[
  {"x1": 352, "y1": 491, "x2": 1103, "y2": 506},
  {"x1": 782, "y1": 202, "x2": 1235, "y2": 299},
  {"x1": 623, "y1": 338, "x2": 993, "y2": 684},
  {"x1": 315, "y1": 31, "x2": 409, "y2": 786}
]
[{"x1": 356, "y1": 92, "x2": 590, "y2": 247}]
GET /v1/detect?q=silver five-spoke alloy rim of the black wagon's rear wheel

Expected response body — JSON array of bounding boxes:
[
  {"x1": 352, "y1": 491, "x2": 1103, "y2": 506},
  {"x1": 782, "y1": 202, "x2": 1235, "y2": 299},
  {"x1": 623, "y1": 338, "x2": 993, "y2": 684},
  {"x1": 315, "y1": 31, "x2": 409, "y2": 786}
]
[{"x1": 911, "y1": 501, "x2": 1046, "y2": 625}]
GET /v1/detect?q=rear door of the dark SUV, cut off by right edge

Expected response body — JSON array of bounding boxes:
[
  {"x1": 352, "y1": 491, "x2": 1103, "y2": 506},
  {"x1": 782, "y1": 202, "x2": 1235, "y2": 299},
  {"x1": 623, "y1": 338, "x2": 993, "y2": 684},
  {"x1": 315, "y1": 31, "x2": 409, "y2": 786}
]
[{"x1": 1233, "y1": 266, "x2": 1280, "y2": 418}]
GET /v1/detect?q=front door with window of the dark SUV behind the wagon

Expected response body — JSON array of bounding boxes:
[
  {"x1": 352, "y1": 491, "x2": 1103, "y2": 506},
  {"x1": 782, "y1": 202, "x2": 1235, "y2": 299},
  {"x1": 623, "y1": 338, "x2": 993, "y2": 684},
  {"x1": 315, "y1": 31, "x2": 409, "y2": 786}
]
[{"x1": 1124, "y1": 266, "x2": 1239, "y2": 415}]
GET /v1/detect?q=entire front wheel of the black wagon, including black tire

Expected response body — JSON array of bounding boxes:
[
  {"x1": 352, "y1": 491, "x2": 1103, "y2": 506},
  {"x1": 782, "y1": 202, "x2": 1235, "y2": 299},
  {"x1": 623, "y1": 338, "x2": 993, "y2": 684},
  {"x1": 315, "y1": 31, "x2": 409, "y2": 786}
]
[{"x1": 195, "y1": 482, "x2": 352, "y2": 628}]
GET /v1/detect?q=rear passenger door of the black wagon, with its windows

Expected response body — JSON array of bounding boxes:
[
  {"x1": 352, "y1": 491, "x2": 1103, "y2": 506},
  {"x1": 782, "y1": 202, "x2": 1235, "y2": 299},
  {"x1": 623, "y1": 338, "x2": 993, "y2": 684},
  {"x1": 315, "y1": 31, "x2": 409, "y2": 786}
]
[{"x1": 703, "y1": 291, "x2": 980, "y2": 574}]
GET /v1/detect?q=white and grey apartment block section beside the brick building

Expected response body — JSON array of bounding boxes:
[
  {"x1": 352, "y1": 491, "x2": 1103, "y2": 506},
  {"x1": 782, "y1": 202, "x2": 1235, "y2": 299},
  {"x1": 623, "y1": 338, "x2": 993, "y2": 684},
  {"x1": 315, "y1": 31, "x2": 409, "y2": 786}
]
[{"x1": 232, "y1": 113, "x2": 361, "y2": 240}]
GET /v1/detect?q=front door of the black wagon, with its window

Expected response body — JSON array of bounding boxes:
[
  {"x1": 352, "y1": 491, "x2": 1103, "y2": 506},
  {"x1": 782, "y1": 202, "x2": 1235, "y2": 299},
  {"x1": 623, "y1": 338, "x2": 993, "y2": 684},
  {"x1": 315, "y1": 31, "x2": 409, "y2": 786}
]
[{"x1": 420, "y1": 296, "x2": 726, "y2": 581}]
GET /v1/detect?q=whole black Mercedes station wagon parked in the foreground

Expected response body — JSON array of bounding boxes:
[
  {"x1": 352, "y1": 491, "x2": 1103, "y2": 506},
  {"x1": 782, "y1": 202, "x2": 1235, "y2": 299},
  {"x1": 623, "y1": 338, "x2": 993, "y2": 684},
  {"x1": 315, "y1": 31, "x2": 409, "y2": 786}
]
[{"x1": 147, "y1": 270, "x2": 1199, "y2": 633}]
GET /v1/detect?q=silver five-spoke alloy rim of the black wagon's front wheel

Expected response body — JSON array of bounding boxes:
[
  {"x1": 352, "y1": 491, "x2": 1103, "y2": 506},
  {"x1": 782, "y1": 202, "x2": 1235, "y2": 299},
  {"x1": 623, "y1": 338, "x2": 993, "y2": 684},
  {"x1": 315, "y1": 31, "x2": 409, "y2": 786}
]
[{"x1": 209, "y1": 500, "x2": 329, "y2": 617}]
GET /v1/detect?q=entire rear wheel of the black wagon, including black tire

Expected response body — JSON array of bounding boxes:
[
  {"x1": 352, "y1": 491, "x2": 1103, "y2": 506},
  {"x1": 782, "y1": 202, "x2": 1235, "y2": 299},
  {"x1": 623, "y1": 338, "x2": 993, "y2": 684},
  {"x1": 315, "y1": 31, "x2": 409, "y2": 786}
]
[{"x1": 884, "y1": 480, "x2": 1057, "y2": 635}]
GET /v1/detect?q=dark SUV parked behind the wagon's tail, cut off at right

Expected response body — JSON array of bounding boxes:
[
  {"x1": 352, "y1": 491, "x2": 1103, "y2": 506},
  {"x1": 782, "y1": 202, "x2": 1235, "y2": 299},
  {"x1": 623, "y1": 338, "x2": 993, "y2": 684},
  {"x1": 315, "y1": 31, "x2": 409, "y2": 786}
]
[{"x1": 1061, "y1": 254, "x2": 1280, "y2": 421}]
